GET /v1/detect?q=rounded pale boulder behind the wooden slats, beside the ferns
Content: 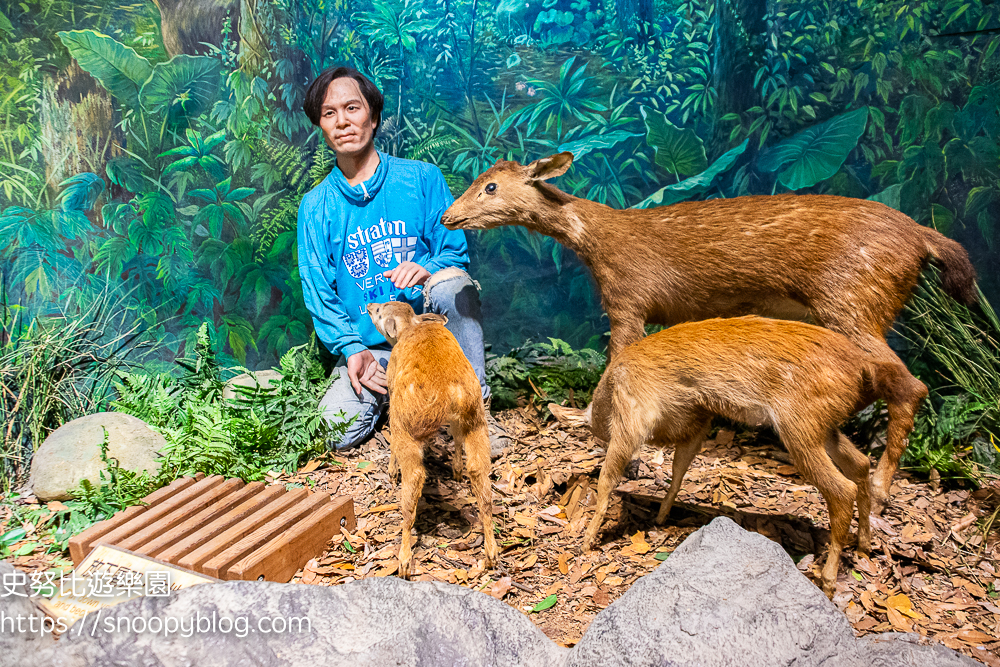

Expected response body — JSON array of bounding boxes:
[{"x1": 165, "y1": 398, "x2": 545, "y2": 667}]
[{"x1": 28, "y1": 412, "x2": 167, "y2": 501}]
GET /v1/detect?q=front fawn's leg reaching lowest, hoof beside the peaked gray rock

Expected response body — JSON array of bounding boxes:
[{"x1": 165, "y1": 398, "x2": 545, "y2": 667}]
[{"x1": 781, "y1": 429, "x2": 858, "y2": 599}]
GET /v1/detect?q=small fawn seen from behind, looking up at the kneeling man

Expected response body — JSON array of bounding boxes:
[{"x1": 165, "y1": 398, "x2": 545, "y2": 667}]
[{"x1": 368, "y1": 301, "x2": 498, "y2": 579}]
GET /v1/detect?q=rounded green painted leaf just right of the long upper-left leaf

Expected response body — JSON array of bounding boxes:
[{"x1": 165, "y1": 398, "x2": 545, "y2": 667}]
[{"x1": 139, "y1": 54, "x2": 222, "y2": 125}]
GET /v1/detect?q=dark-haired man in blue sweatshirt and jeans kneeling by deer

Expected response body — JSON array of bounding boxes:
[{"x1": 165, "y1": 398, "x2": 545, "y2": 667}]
[{"x1": 298, "y1": 67, "x2": 510, "y2": 456}]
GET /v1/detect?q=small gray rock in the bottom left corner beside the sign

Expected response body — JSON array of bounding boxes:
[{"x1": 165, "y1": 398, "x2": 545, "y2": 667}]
[{"x1": 0, "y1": 561, "x2": 56, "y2": 665}]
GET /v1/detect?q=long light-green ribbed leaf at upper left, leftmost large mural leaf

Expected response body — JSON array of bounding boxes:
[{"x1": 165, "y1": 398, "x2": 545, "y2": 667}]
[{"x1": 57, "y1": 30, "x2": 153, "y2": 108}]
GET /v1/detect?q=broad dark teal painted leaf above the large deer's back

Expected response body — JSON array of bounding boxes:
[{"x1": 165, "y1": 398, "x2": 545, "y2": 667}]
[{"x1": 757, "y1": 107, "x2": 868, "y2": 190}]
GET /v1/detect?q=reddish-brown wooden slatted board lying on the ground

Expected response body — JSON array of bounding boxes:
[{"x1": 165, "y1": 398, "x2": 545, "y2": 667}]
[{"x1": 69, "y1": 474, "x2": 356, "y2": 582}]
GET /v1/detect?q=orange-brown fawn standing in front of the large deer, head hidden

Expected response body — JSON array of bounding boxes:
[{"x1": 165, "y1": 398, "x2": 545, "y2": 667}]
[{"x1": 584, "y1": 316, "x2": 927, "y2": 597}]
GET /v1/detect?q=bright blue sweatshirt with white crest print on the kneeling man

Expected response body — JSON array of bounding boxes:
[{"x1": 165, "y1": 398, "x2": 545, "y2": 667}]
[{"x1": 298, "y1": 152, "x2": 469, "y2": 357}]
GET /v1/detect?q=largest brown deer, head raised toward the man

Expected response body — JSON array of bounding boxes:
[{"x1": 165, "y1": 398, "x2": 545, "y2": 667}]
[{"x1": 441, "y1": 152, "x2": 976, "y2": 512}]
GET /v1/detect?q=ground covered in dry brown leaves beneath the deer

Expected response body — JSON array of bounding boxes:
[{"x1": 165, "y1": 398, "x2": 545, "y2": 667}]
[{"x1": 0, "y1": 407, "x2": 1000, "y2": 667}]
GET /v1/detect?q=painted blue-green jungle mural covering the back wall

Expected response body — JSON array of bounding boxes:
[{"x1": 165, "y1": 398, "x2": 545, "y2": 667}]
[{"x1": 0, "y1": 0, "x2": 1000, "y2": 480}]
